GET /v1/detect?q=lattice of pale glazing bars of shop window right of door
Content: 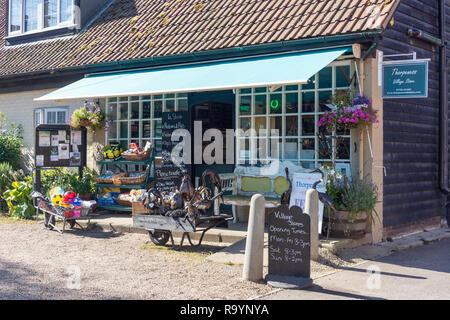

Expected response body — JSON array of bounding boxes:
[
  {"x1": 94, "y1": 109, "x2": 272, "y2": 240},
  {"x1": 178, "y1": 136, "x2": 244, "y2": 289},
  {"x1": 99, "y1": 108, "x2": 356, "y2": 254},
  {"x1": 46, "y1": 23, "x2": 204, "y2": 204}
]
[{"x1": 235, "y1": 60, "x2": 354, "y2": 168}]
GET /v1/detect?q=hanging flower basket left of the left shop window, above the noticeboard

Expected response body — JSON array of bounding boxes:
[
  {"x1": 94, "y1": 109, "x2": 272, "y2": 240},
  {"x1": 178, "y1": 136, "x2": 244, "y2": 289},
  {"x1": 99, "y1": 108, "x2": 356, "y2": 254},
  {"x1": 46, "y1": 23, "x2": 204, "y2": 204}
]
[{"x1": 69, "y1": 102, "x2": 113, "y2": 131}]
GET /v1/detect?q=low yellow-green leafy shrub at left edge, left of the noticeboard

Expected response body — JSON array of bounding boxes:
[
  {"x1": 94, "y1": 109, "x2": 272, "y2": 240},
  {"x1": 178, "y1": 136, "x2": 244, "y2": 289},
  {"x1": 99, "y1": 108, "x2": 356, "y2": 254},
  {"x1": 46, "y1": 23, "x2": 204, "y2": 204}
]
[{"x1": 3, "y1": 177, "x2": 35, "y2": 219}]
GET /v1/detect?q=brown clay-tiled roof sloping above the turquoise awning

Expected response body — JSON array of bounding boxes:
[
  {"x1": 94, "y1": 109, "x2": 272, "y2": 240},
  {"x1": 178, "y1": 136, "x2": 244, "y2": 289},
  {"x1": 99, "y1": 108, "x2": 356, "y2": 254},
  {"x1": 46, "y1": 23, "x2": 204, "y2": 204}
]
[{"x1": 0, "y1": 0, "x2": 399, "y2": 76}]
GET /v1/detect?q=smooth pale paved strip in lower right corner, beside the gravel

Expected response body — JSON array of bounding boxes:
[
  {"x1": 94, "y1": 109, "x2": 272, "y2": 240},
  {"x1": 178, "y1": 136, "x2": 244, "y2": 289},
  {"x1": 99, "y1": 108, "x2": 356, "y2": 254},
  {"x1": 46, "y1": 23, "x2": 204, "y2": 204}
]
[{"x1": 258, "y1": 235, "x2": 450, "y2": 300}]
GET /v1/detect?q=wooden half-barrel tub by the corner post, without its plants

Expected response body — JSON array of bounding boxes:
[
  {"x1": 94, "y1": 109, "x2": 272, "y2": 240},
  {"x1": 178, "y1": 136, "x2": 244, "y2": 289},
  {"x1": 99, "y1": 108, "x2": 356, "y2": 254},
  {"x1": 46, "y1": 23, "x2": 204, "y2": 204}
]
[{"x1": 323, "y1": 211, "x2": 367, "y2": 239}]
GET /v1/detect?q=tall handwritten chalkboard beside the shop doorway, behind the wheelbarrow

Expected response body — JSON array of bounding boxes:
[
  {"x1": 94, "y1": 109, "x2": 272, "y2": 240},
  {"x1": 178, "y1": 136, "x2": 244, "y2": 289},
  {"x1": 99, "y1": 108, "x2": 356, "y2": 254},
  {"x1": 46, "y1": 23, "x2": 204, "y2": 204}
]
[{"x1": 155, "y1": 111, "x2": 191, "y2": 192}]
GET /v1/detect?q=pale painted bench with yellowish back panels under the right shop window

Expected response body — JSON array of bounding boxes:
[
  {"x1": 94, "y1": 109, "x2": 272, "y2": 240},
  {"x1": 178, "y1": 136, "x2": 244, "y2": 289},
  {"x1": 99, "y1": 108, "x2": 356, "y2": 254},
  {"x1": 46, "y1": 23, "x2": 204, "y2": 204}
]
[{"x1": 215, "y1": 161, "x2": 308, "y2": 223}]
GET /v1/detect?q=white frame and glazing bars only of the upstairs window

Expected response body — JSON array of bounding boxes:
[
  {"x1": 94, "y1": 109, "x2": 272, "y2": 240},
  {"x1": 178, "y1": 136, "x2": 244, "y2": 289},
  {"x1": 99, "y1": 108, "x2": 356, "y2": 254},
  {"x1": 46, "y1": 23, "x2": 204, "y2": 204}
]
[{"x1": 8, "y1": 0, "x2": 75, "y2": 36}]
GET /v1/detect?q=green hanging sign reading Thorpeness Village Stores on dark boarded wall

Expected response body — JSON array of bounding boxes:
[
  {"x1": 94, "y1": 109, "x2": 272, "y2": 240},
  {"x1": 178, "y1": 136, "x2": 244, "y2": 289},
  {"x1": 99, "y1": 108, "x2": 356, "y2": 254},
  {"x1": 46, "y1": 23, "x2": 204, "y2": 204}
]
[{"x1": 382, "y1": 60, "x2": 428, "y2": 99}]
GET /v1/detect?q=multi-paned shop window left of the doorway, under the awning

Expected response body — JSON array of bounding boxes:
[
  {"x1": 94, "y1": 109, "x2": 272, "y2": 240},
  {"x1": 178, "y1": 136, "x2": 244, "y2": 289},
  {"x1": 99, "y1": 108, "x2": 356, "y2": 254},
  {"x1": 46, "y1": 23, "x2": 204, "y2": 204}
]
[{"x1": 106, "y1": 94, "x2": 188, "y2": 156}]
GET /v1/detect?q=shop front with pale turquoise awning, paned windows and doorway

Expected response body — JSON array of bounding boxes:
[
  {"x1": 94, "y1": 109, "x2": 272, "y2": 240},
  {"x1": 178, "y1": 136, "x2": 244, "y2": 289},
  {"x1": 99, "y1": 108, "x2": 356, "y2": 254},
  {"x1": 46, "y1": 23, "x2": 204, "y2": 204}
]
[{"x1": 36, "y1": 47, "x2": 357, "y2": 181}]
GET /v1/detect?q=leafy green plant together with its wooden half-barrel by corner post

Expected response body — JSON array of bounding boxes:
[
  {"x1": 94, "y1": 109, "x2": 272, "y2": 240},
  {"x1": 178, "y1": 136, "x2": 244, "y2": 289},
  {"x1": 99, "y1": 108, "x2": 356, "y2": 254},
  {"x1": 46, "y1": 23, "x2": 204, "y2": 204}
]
[{"x1": 324, "y1": 177, "x2": 379, "y2": 238}]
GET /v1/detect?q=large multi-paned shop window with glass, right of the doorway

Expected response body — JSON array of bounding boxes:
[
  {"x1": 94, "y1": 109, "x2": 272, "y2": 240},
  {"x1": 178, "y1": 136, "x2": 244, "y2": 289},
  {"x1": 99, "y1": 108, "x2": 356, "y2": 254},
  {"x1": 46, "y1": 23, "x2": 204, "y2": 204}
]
[{"x1": 236, "y1": 62, "x2": 351, "y2": 168}]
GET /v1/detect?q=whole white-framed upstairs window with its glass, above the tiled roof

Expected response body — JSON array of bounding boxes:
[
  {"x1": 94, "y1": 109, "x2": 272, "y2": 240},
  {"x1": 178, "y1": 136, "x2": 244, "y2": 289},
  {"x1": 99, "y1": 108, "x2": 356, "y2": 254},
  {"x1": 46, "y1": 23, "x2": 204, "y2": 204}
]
[{"x1": 9, "y1": 0, "x2": 74, "y2": 35}]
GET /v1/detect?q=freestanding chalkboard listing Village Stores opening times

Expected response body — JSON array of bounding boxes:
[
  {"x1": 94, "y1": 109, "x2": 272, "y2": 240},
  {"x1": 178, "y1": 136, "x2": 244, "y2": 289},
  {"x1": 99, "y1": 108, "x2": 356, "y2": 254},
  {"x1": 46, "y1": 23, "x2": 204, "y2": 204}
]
[{"x1": 269, "y1": 205, "x2": 311, "y2": 278}]
